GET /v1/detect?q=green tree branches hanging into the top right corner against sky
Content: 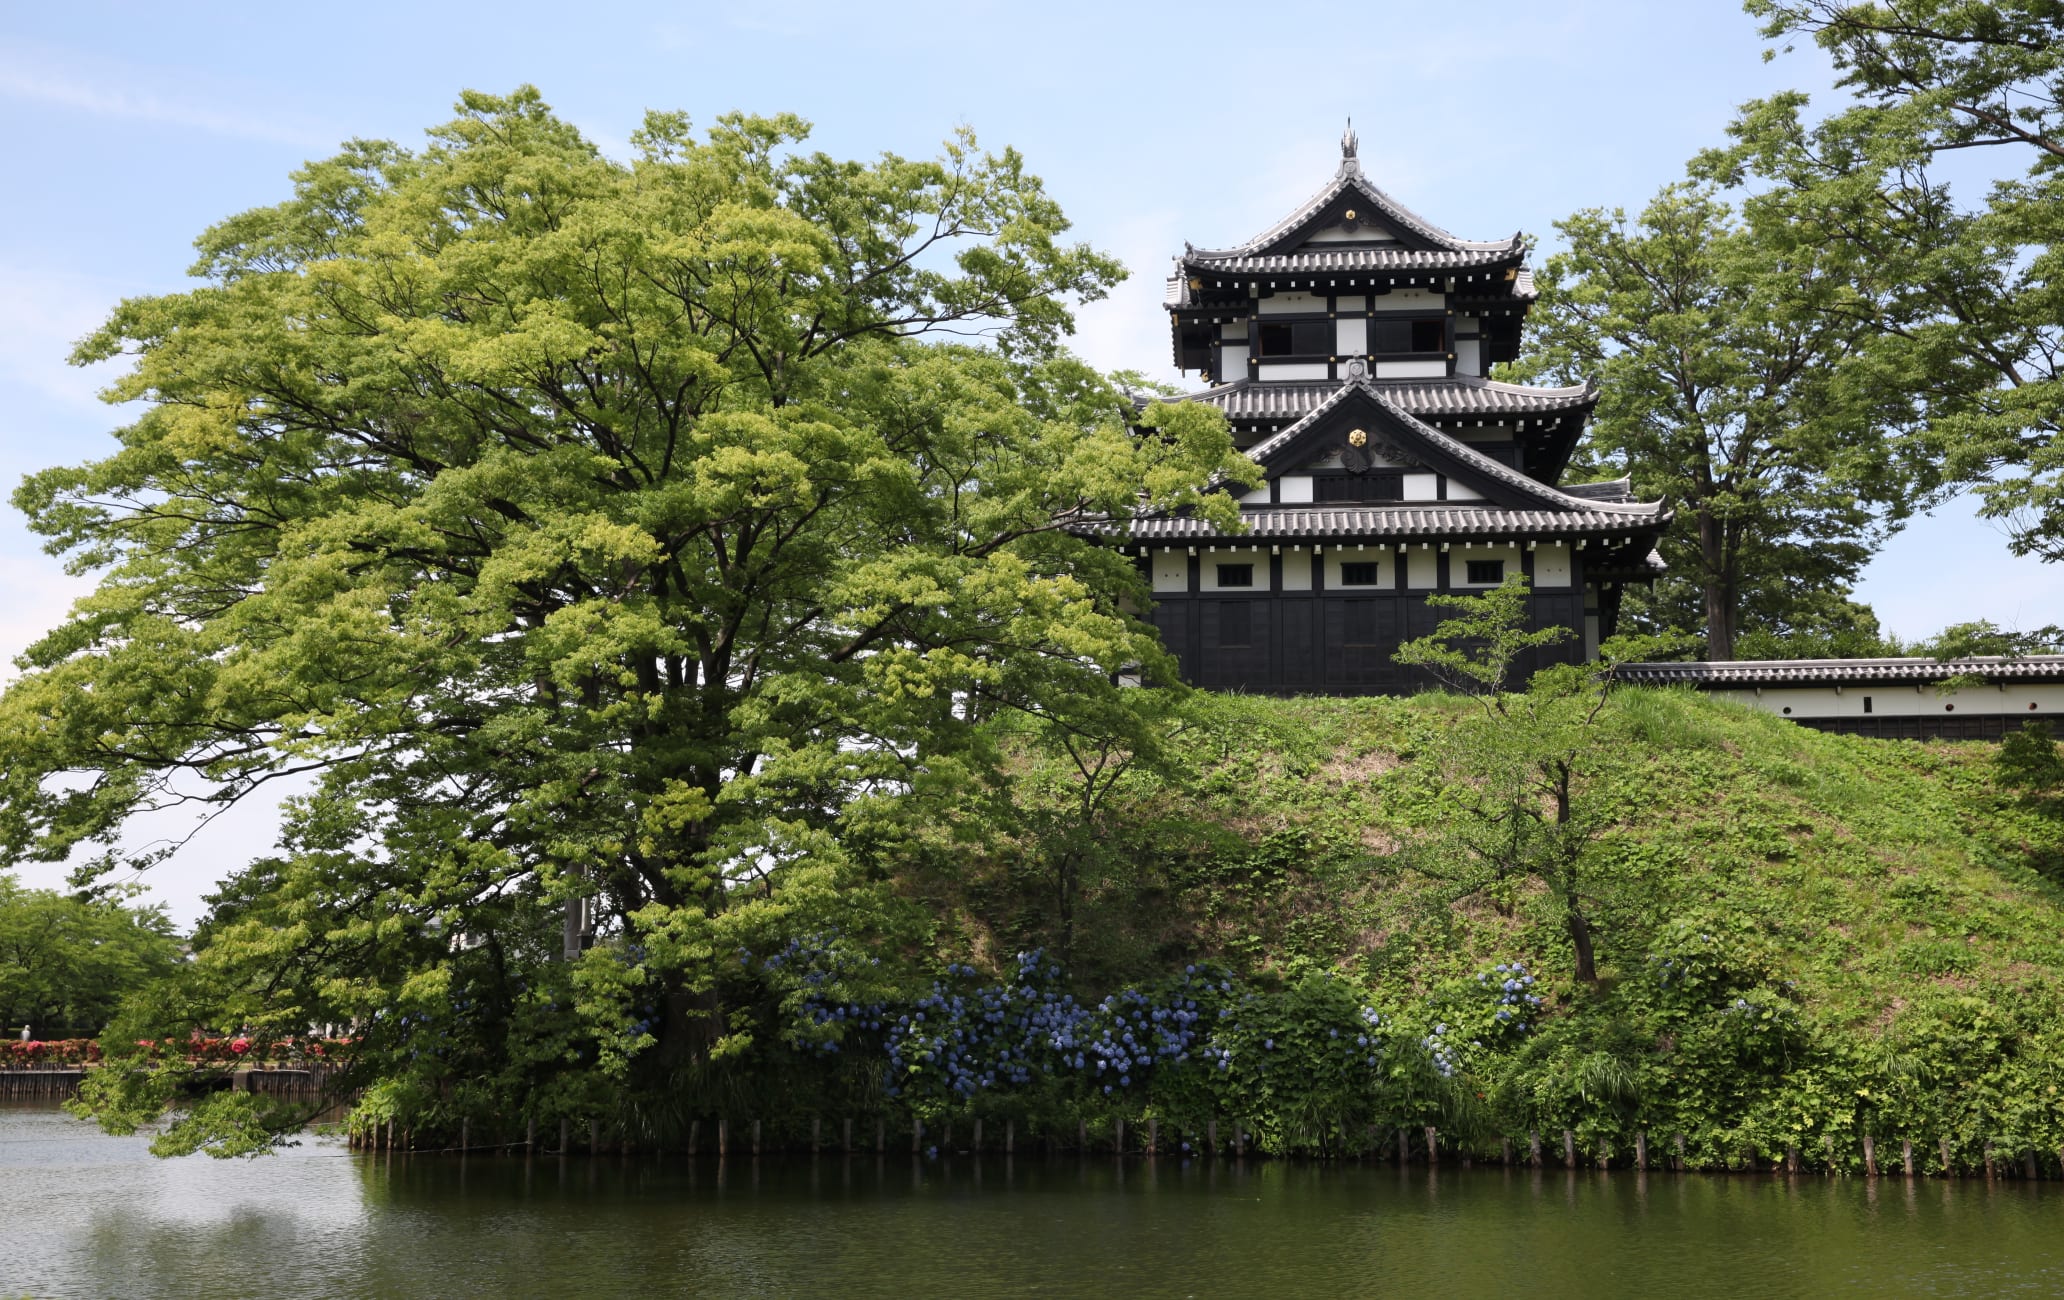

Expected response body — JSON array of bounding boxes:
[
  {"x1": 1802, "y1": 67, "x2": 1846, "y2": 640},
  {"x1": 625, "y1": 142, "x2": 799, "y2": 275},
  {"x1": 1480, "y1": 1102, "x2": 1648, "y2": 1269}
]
[{"x1": 1703, "y1": 0, "x2": 2064, "y2": 559}]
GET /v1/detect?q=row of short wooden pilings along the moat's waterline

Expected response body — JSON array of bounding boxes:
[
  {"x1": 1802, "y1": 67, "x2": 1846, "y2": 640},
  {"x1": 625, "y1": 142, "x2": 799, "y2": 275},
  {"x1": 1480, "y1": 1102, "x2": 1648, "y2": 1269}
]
[{"x1": 338, "y1": 1116, "x2": 2064, "y2": 1180}]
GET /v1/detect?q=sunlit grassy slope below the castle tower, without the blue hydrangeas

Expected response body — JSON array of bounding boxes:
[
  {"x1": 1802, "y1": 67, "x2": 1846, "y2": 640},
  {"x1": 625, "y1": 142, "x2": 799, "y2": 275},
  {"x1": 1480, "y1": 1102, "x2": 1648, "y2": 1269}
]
[{"x1": 912, "y1": 691, "x2": 2064, "y2": 1176}]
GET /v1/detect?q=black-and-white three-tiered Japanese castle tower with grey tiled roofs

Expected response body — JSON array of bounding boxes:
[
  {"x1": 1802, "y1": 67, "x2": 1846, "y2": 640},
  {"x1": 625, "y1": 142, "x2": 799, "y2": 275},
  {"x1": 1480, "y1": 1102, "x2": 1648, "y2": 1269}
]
[{"x1": 1129, "y1": 126, "x2": 1670, "y2": 693}]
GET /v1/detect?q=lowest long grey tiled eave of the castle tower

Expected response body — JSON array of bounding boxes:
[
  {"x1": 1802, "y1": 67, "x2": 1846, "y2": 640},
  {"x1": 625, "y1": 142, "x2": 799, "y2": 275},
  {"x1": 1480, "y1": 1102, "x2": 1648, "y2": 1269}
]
[{"x1": 1129, "y1": 503, "x2": 1651, "y2": 541}]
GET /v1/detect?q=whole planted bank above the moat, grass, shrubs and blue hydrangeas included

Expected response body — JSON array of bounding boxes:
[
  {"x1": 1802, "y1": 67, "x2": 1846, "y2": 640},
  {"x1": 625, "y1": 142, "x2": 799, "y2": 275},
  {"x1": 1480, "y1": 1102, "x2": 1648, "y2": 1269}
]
[{"x1": 44, "y1": 689, "x2": 2064, "y2": 1178}]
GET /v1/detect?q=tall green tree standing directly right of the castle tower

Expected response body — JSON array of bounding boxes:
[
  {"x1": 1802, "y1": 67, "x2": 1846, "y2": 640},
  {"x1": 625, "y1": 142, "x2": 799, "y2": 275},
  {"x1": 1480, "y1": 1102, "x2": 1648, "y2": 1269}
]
[{"x1": 1513, "y1": 184, "x2": 1928, "y2": 658}]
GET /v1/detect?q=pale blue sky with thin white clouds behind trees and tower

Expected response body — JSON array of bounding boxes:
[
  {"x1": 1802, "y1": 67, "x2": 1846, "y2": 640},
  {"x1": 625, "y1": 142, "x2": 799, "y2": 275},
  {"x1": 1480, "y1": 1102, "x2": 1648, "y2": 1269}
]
[{"x1": 0, "y1": 0, "x2": 2064, "y2": 920}]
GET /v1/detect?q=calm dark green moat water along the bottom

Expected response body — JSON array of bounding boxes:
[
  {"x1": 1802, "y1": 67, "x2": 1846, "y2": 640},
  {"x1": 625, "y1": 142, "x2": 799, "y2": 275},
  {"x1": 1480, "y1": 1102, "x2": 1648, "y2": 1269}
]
[{"x1": 0, "y1": 1106, "x2": 2064, "y2": 1298}]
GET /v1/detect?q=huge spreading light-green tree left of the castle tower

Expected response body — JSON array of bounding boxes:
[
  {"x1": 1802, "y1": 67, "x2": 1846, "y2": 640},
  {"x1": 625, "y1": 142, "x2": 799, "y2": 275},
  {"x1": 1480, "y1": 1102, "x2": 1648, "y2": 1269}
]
[{"x1": 0, "y1": 89, "x2": 1251, "y2": 1147}]
